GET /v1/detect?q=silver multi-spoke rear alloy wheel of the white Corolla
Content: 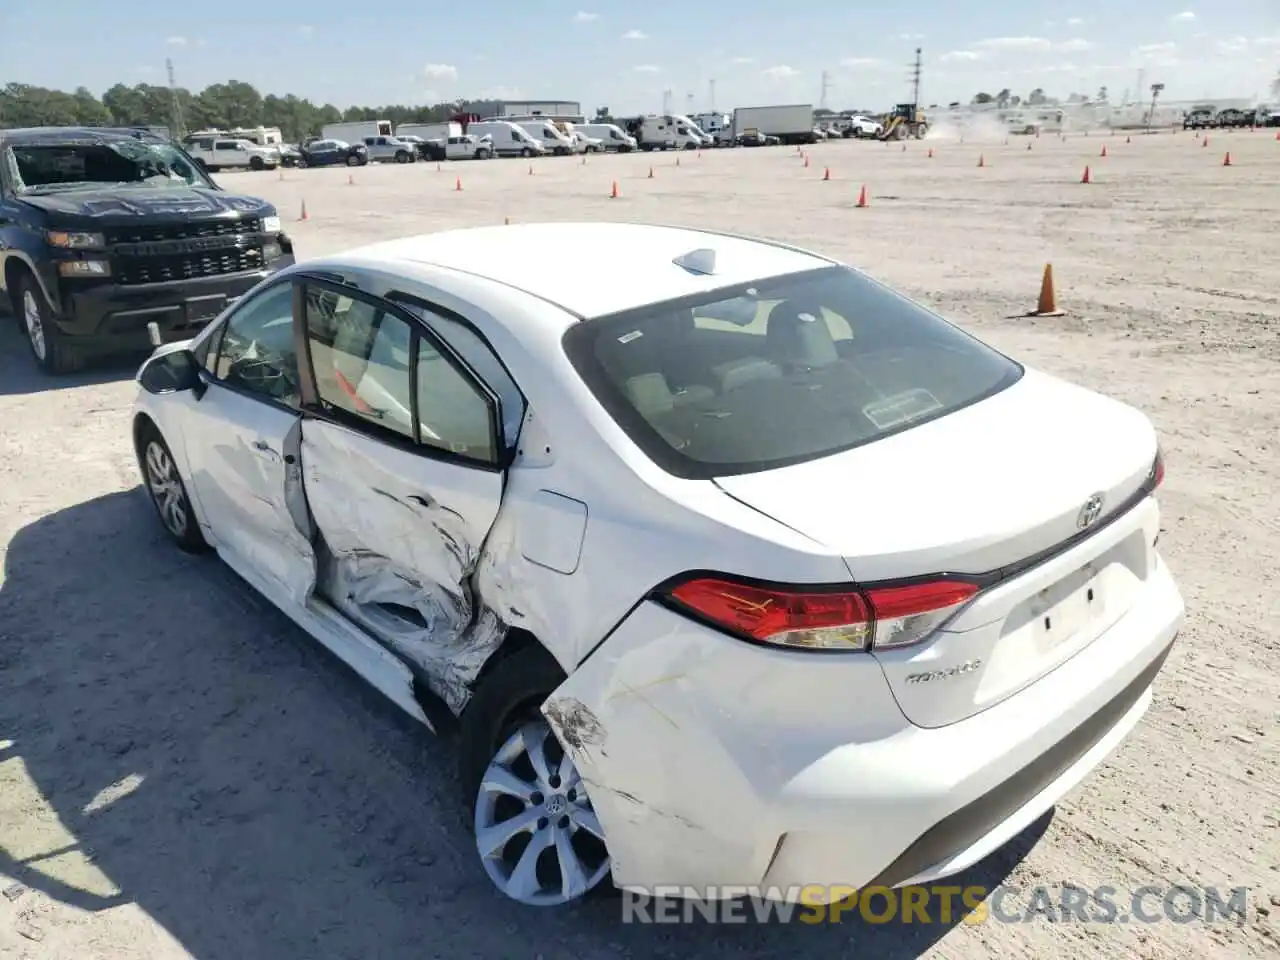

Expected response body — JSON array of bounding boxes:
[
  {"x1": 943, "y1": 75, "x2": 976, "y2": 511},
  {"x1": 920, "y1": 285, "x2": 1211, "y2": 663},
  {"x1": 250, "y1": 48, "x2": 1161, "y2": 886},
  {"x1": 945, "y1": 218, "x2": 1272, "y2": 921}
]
[{"x1": 475, "y1": 719, "x2": 609, "y2": 906}]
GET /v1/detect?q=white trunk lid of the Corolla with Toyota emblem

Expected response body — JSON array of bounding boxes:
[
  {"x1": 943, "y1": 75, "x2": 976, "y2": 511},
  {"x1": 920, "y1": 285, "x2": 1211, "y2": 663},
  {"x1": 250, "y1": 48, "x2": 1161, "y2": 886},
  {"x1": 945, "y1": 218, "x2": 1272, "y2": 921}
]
[{"x1": 716, "y1": 371, "x2": 1158, "y2": 727}]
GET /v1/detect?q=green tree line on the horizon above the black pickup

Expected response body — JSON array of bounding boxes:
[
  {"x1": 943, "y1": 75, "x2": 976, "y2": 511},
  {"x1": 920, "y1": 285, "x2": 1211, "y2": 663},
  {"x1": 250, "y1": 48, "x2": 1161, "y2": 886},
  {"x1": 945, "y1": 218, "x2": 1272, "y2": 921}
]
[{"x1": 0, "y1": 79, "x2": 502, "y2": 142}]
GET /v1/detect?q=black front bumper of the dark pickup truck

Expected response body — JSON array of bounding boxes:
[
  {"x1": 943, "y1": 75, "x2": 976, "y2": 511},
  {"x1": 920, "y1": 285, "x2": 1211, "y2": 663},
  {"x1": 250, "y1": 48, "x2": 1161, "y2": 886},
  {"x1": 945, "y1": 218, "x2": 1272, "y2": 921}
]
[{"x1": 48, "y1": 253, "x2": 294, "y2": 352}]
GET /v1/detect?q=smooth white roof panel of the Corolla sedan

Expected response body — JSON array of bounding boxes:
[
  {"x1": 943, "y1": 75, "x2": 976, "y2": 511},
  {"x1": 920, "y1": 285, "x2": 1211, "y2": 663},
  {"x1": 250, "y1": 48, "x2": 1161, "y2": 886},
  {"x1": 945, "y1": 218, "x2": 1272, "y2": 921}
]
[{"x1": 332, "y1": 223, "x2": 835, "y2": 317}]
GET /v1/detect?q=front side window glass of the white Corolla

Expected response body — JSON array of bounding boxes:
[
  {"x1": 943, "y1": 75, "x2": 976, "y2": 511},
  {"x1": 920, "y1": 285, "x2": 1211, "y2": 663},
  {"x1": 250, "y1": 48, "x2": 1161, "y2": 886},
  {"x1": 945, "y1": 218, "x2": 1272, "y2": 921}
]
[{"x1": 211, "y1": 283, "x2": 301, "y2": 408}]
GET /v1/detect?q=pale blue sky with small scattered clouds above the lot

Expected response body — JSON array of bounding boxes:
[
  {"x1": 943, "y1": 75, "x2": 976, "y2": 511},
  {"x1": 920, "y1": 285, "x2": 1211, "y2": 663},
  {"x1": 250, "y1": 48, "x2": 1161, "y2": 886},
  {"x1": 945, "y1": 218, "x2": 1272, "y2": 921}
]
[{"x1": 0, "y1": 0, "x2": 1280, "y2": 113}]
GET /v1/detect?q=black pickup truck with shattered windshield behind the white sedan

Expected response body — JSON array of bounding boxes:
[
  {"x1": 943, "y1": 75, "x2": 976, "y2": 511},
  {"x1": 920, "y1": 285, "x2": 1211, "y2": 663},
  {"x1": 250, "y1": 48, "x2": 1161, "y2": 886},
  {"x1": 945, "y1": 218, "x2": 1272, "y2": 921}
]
[{"x1": 0, "y1": 127, "x2": 293, "y2": 374}]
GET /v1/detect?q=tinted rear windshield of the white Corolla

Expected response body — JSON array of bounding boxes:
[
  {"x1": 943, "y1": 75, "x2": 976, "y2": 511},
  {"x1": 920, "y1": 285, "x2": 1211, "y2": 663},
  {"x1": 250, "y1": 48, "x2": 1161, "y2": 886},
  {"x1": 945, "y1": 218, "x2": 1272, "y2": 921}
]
[{"x1": 564, "y1": 266, "x2": 1023, "y2": 479}]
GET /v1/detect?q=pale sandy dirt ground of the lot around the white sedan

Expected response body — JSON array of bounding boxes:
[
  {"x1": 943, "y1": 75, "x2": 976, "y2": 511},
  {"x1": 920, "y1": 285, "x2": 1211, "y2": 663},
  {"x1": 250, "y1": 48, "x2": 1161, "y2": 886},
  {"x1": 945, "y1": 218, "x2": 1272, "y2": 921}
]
[{"x1": 0, "y1": 131, "x2": 1280, "y2": 960}]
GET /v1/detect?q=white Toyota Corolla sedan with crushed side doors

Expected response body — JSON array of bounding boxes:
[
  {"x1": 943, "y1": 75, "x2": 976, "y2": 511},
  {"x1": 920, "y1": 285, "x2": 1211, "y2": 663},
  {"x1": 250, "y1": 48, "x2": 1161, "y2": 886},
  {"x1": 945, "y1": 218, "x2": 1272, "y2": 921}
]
[{"x1": 133, "y1": 223, "x2": 1183, "y2": 905}]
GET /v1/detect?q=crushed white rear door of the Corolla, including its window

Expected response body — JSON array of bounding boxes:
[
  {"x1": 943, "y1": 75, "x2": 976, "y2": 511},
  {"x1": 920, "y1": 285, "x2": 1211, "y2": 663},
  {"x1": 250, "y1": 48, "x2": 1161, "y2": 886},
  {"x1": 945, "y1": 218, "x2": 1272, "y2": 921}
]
[{"x1": 302, "y1": 279, "x2": 517, "y2": 712}]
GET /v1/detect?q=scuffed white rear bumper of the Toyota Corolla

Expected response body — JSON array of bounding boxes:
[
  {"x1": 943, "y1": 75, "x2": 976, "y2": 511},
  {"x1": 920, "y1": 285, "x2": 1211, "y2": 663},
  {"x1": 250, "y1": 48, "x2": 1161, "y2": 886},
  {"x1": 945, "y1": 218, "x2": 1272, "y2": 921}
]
[{"x1": 543, "y1": 555, "x2": 1183, "y2": 902}]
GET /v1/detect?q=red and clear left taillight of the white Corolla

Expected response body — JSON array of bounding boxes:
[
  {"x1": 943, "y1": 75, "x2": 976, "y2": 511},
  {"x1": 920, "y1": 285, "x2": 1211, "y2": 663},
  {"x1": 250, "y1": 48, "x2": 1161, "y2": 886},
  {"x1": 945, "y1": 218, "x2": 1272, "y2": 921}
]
[{"x1": 666, "y1": 577, "x2": 978, "y2": 650}]
